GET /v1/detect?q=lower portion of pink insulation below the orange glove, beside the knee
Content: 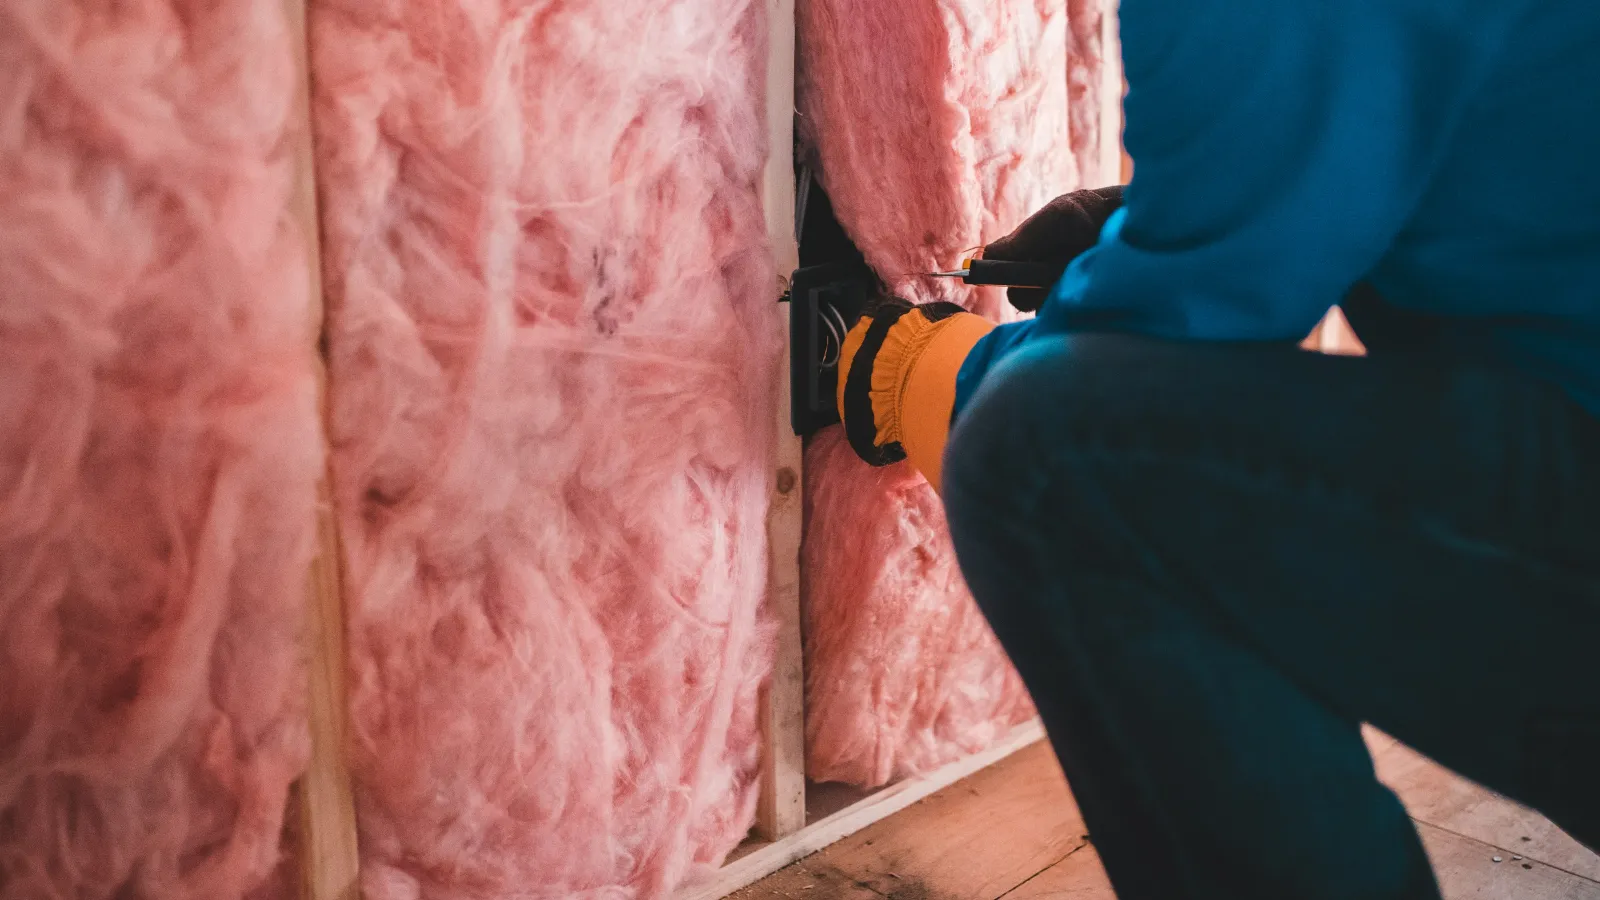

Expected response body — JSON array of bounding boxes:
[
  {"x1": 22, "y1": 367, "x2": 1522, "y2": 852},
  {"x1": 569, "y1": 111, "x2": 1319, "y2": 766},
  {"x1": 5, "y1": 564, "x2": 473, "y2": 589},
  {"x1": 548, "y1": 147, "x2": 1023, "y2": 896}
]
[{"x1": 803, "y1": 428, "x2": 1032, "y2": 785}]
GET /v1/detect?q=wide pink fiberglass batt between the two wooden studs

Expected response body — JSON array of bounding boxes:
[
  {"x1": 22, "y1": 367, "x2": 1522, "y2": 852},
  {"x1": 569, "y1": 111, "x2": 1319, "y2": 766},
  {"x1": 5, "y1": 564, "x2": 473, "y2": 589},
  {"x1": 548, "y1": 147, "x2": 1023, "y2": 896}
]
[{"x1": 312, "y1": 0, "x2": 779, "y2": 900}]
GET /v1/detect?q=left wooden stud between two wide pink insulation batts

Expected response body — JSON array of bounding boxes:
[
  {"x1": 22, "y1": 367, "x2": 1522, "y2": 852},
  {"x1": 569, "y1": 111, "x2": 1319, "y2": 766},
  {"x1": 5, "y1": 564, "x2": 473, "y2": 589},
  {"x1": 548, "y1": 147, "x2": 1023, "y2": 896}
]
[{"x1": 283, "y1": 0, "x2": 360, "y2": 900}]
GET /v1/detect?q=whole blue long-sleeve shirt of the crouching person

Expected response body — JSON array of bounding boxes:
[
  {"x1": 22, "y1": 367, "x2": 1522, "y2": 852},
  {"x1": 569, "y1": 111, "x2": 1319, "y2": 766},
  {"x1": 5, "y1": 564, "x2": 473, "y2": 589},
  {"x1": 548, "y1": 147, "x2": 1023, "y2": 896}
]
[{"x1": 957, "y1": 0, "x2": 1600, "y2": 413}]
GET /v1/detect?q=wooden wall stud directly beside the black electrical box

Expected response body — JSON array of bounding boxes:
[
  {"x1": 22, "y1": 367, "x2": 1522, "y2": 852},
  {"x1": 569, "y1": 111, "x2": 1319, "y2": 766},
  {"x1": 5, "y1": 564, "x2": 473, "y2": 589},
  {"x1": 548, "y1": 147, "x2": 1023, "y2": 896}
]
[{"x1": 755, "y1": 0, "x2": 805, "y2": 839}]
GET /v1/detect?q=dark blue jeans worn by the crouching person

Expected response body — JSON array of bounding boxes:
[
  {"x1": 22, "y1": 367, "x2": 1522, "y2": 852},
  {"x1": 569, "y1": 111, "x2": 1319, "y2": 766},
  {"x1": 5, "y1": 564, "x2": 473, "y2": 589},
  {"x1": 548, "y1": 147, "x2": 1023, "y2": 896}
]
[{"x1": 944, "y1": 335, "x2": 1600, "y2": 900}]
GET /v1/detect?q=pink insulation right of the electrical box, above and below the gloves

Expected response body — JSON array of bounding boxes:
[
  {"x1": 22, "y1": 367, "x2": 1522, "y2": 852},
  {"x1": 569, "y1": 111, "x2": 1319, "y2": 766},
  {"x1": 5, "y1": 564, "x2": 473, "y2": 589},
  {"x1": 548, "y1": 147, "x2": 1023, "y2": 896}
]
[{"x1": 798, "y1": 0, "x2": 1114, "y2": 786}]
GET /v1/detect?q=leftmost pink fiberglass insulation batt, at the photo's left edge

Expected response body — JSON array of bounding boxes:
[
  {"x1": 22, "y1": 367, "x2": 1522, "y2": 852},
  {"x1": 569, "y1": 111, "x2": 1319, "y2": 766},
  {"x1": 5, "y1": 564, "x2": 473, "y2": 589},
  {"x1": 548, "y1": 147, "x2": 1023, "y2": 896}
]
[{"x1": 0, "y1": 0, "x2": 322, "y2": 900}]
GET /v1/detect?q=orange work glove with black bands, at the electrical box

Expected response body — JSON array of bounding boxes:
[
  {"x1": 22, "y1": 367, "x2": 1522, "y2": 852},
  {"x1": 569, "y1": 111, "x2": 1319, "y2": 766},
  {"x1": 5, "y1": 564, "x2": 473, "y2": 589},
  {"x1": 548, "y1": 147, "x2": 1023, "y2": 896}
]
[{"x1": 838, "y1": 296, "x2": 994, "y2": 490}]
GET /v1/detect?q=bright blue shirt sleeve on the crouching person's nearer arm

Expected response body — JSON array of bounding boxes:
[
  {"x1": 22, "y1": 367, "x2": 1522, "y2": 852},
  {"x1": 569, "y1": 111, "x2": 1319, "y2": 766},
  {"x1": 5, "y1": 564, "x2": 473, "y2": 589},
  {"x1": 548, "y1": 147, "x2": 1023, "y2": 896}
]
[{"x1": 955, "y1": 0, "x2": 1517, "y2": 410}]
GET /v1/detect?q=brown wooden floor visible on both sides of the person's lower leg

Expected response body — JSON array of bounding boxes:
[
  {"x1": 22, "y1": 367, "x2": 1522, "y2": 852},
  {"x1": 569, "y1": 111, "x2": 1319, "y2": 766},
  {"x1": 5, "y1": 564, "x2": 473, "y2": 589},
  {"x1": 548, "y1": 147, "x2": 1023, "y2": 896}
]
[{"x1": 733, "y1": 732, "x2": 1600, "y2": 900}]
